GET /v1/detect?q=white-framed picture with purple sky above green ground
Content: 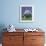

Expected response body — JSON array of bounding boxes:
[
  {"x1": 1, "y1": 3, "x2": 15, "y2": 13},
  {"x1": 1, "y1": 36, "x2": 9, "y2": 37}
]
[{"x1": 20, "y1": 5, "x2": 34, "y2": 22}]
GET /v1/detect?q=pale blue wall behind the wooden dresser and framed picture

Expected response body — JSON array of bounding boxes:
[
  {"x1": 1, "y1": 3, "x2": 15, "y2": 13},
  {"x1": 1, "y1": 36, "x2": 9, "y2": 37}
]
[{"x1": 0, "y1": 0, "x2": 46, "y2": 28}]
